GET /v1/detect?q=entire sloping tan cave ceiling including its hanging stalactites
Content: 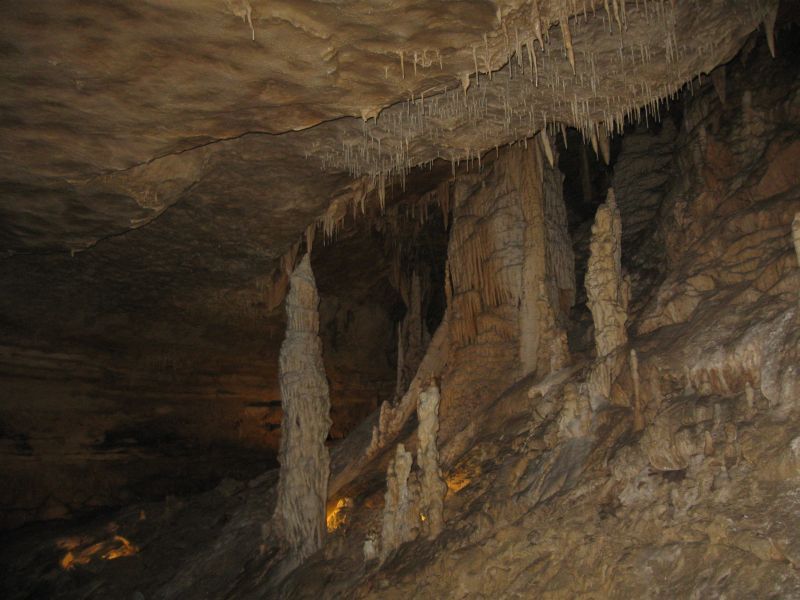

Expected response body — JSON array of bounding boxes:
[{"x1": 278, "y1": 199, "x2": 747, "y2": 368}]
[{"x1": 0, "y1": 0, "x2": 777, "y2": 318}]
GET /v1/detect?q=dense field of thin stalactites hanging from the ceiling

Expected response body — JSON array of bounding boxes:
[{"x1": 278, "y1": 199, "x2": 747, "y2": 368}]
[{"x1": 322, "y1": 0, "x2": 778, "y2": 195}]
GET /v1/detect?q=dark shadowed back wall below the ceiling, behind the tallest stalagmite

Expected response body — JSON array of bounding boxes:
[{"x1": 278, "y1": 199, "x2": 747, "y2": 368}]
[{"x1": 0, "y1": 232, "x2": 404, "y2": 528}]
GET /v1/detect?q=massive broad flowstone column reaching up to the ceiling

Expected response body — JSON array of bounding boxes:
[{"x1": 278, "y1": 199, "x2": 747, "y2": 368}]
[{"x1": 442, "y1": 142, "x2": 575, "y2": 436}]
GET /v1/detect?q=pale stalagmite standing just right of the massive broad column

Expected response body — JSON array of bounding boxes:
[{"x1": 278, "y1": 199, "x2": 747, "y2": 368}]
[{"x1": 586, "y1": 189, "x2": 628, "y2": 358}]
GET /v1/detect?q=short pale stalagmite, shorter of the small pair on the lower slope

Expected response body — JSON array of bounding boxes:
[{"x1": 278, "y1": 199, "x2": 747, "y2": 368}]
[{"x1": 380, "y1": 444, "x2": 419, "y2": 561}]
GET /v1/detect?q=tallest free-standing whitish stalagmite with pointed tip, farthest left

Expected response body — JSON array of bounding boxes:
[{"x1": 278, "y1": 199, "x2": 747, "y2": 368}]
[{"x1": 274, "y1": 254, "x2": 331, "y2": 560}]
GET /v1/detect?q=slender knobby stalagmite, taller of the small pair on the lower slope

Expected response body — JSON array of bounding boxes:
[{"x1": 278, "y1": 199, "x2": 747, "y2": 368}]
[{"x1": 417, "y1": 384, "x2": 447, "y2": 539}]
